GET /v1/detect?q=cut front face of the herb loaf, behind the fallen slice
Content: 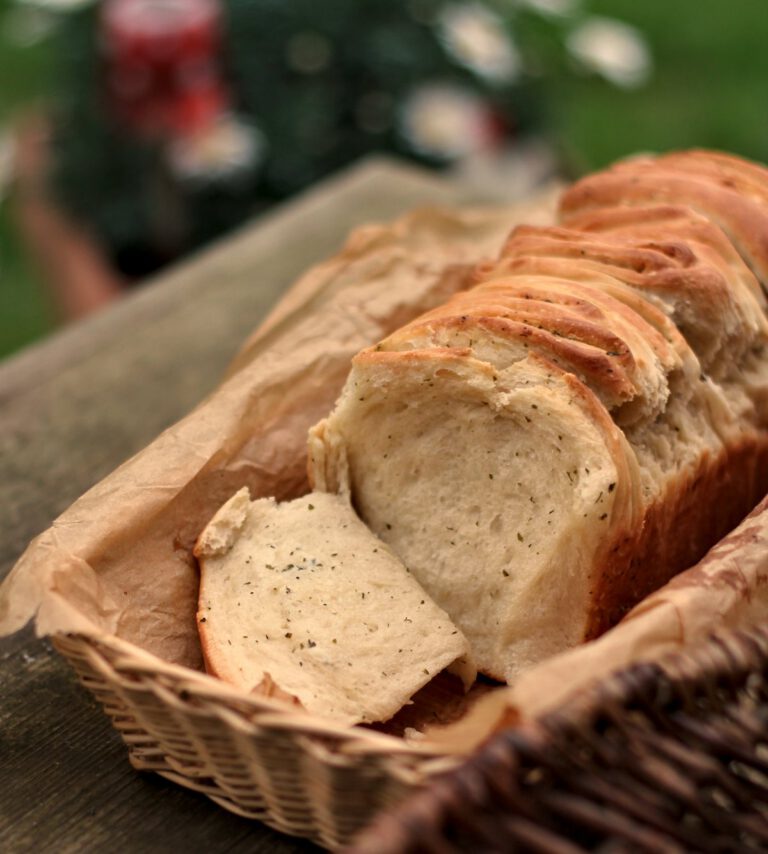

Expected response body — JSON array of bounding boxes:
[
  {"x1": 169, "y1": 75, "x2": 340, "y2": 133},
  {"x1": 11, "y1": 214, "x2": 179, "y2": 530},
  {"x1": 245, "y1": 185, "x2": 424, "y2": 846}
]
[{"x1": 310, "y1": 348, "x2": 641, "y2": 681}]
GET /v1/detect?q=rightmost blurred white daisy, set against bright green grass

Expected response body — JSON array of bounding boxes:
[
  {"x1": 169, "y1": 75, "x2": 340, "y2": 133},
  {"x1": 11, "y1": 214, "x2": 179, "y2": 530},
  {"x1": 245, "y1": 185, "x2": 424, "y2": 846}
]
[{"x1": 567, "y1": 17, "x2": 652, "y2": 88}]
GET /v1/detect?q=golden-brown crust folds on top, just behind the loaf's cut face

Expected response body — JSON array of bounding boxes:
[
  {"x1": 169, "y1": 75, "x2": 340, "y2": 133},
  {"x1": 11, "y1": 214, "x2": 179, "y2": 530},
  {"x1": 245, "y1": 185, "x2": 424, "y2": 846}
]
[{"x1": 380, "y1": 271, "x2": 689, "y2": 422}]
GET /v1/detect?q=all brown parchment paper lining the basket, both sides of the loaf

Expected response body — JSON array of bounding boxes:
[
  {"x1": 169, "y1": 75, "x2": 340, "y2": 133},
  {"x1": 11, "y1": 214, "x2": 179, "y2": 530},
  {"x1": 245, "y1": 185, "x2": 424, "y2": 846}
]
[{"x1": 0, "y1": 190, "x2": 768, "y2": 752}]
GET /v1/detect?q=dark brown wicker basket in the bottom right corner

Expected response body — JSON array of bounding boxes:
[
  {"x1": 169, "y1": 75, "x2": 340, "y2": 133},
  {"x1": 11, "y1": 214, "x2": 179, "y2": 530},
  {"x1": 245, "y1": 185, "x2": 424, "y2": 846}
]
[{"x1": 352, "y1": 626, "x2": 768, "y2": 854}]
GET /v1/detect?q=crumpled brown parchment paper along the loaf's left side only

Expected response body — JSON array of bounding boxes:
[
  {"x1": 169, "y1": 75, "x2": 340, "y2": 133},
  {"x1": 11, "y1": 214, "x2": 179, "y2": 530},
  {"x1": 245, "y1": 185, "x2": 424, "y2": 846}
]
[{"x1": 0, "y1": 197, "x2": 555, "y2": 668}]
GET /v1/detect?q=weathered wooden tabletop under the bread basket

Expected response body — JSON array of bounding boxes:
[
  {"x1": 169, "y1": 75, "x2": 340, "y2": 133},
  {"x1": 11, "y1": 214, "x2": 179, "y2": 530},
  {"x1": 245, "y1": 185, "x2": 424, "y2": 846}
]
[{"x1": 0, "y1": 159, "x2": 480, "y2": 854}]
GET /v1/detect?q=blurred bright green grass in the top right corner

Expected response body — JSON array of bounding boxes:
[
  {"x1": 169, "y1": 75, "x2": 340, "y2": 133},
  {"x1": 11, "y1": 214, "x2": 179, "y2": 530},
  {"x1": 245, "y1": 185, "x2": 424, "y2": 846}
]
[{"x1": 553, "y1": 0, "x2": 768, "y2": 174}]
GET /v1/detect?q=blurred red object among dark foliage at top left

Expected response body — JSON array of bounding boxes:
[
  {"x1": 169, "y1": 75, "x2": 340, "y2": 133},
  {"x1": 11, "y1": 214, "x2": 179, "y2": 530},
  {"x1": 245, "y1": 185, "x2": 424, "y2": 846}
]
[{"x1": 101, "y1": 0, "x2": 229, "y2": 137}]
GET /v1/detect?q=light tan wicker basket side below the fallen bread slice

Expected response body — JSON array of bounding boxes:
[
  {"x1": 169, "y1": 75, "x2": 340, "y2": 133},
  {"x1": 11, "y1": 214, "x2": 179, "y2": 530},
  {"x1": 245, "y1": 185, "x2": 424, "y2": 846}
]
[{"x1": 53, "y1": 634, "x2": 459, "y2": 849}]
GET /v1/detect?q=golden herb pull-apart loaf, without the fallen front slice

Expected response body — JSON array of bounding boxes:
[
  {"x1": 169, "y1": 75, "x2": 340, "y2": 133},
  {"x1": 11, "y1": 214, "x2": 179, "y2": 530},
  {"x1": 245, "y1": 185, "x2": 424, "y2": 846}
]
[{"x1": 310, "y1": 147, "x2": 768, "y2": 681}]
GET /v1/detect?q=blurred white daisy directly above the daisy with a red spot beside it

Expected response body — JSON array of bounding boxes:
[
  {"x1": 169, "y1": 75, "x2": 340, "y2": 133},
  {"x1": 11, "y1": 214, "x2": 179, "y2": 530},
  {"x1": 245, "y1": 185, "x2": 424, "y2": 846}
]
[{"x1": 437, "y1": 3, "x2": 521, "y2": 83}]
